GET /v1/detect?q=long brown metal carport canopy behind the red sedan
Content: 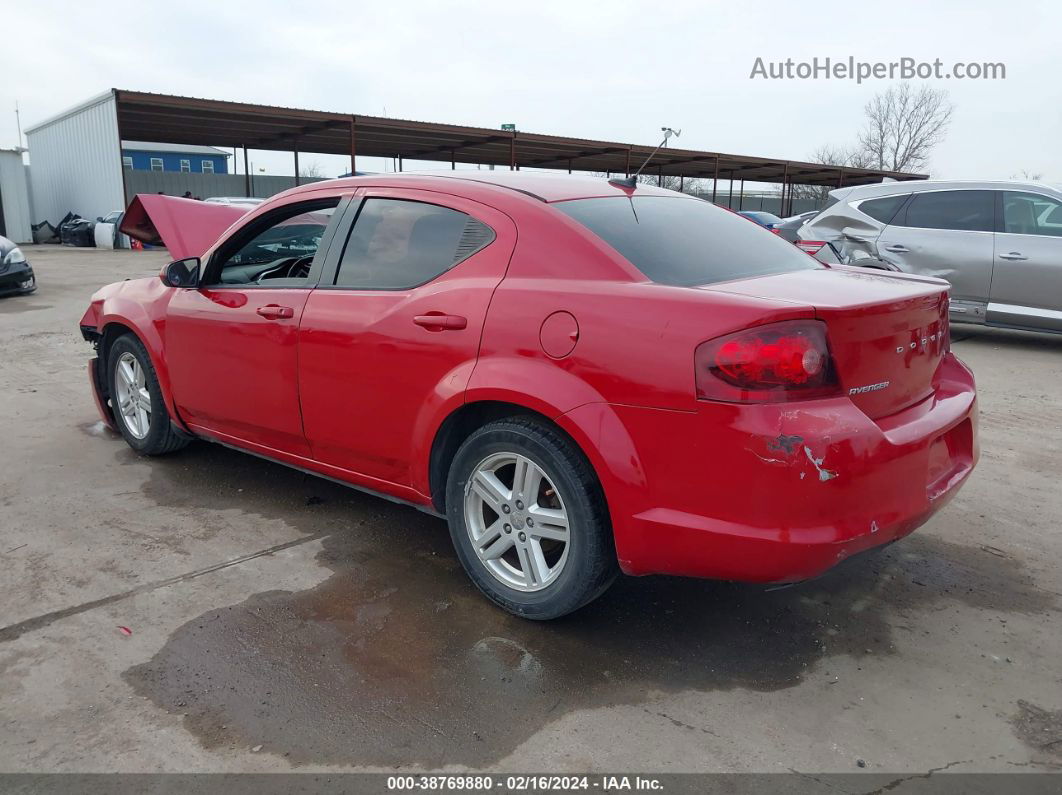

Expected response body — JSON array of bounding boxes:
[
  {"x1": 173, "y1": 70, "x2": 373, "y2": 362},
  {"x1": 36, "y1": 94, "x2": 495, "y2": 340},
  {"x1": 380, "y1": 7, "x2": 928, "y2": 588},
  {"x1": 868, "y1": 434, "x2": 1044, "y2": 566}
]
[{"x1": 113, "y1": 89, "x2": 926, "y2": 187}]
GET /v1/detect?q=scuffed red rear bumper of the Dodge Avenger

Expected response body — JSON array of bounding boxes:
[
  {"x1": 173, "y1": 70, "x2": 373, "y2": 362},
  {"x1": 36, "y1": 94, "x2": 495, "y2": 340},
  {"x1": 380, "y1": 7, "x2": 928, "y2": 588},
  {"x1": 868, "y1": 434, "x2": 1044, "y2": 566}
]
[{"x1": 569, "y1": 355, "x2": 978, "y2": 583}]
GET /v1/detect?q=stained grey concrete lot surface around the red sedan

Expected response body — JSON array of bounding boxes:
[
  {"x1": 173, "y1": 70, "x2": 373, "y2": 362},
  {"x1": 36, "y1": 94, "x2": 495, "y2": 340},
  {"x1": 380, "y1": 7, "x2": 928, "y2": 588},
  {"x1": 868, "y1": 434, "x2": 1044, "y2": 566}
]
[{"x1": 0, "y1": 246, "x2": 1062, "y2": 773}]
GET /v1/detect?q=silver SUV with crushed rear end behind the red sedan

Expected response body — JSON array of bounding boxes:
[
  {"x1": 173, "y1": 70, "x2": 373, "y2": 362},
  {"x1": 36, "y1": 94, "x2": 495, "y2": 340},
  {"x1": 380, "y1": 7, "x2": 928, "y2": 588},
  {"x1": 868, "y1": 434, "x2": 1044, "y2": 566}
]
[{"x1": 799, "y1": 182, "x2": 1062, "y2": 332}]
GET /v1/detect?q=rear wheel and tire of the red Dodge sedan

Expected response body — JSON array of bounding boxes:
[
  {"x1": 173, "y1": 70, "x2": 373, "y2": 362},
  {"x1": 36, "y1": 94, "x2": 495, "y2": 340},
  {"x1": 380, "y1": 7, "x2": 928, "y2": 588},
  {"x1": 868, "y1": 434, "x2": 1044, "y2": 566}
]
[{"x1": 446, "y1": 417, "x2": 618, "y2": 621}]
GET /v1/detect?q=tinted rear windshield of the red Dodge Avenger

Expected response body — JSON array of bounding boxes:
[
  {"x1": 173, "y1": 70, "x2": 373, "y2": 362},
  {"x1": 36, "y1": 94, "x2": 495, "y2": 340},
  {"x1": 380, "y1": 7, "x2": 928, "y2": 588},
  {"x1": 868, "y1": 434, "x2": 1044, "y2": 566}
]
[{"x1": 553, "y1": 196, "x2": 821, "y2": 287}]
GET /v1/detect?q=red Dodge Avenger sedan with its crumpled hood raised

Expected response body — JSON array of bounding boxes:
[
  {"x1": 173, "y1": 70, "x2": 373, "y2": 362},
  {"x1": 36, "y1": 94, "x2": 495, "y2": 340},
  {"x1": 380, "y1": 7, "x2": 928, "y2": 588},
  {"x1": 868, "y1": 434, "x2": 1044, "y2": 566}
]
[{"x1": 82, "y1": 171, "x2": 977, "y2": 619}]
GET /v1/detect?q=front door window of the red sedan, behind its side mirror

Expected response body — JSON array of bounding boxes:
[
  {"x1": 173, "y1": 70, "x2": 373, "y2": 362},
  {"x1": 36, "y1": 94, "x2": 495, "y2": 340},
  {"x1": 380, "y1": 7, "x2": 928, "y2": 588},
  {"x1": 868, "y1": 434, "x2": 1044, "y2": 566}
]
[{"x1": 208, "y1": 197, "x2": 339, "y2": 287}]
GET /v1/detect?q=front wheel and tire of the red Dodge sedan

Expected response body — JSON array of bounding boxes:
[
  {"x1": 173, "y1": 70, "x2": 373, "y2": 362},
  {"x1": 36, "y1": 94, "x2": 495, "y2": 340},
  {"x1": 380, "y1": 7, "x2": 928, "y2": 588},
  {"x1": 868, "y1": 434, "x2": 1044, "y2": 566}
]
[{"x1": 107, "y1": 334, "x2": 189, "y2": 455}]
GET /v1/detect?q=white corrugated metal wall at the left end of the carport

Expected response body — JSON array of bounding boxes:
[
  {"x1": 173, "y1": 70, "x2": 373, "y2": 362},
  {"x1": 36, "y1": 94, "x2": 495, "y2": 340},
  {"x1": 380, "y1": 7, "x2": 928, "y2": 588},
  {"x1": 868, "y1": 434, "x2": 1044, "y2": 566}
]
[{"x1": 25, "y1": 93, "x2": 125, "y2": 225}]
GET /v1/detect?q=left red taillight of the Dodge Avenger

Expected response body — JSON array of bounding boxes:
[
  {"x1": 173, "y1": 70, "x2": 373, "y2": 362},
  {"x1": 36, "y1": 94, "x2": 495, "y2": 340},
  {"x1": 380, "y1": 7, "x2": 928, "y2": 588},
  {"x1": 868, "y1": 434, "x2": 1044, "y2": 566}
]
[{"x1": 693, "y1": 321, "x2": 838, "y2": 403}]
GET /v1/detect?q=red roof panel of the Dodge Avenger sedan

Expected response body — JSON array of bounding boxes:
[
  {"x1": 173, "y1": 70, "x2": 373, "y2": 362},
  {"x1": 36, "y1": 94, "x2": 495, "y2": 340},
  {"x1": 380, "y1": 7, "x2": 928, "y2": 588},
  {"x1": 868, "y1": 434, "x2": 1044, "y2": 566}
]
[{"x1": 285, "y1": 169, "x2": 684, "y2": 202}]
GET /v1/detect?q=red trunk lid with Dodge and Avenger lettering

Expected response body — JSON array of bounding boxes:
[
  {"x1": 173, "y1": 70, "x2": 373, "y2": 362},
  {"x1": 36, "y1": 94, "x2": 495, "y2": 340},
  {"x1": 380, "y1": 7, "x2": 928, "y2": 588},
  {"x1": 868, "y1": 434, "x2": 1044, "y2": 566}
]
[{"x1": 708, "y1": 266, "x2": 948, "y2": 417}]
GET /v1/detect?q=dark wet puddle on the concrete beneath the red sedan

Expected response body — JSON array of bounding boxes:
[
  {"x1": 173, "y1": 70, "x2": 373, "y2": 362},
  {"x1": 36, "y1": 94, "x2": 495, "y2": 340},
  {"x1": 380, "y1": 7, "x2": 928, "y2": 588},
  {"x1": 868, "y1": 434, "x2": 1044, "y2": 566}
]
[{"x1": 124, "y1": 444, "x2": 1054, "y2": 767}]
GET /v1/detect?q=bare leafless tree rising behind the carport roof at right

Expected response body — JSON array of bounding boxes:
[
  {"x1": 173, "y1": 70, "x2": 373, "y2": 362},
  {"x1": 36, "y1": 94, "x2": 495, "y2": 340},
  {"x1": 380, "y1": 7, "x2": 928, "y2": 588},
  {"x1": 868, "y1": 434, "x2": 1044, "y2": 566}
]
[{"x1": 859, "y1": 83, "x2": 954, "y2": 171}]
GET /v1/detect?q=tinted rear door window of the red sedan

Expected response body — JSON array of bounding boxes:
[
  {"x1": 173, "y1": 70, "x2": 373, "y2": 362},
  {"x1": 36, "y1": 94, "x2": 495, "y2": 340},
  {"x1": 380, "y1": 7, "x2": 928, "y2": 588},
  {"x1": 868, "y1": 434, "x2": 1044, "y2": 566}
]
[{"x1": 336, "y1": 198, "x2": 494, "y2": 290}]
